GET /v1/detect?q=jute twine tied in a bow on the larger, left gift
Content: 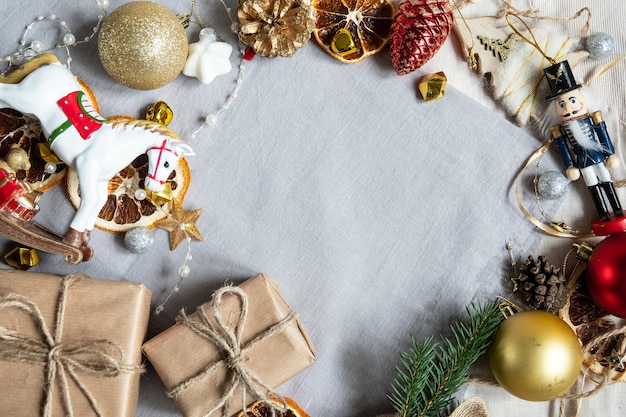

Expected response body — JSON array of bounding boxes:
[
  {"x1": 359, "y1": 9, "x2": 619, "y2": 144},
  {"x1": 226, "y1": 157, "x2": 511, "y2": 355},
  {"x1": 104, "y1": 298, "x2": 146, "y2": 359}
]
[{"x1": 0, "y1": 274, "x2": 143, "y2": 417}]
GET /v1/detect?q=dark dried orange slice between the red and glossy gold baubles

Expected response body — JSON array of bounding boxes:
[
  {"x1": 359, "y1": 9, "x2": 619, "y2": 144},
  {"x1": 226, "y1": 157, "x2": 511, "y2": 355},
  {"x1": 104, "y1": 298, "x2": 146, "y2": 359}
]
[{"x1": 559, "y1": 270, "x2": 626, "y2": 382}]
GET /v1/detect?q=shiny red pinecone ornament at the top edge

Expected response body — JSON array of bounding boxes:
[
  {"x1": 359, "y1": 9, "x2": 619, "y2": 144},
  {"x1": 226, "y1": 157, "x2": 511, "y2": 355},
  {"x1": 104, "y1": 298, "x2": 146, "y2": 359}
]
[{"x1": 389, "y1": 0, "x2": 452, "y2": 75}]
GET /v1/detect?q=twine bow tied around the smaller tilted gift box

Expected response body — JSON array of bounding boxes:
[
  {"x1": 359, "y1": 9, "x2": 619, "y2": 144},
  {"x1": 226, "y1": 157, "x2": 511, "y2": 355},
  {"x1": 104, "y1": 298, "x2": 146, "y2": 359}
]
[{"x1": 167, "y1": 286, "x2": 297, "y2": 417}]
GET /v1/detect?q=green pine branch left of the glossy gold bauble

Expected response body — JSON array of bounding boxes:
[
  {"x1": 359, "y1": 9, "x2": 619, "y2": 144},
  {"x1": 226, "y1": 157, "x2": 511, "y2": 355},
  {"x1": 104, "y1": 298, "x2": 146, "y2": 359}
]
[{"x1": 389, "y1": 302, "x2": 503, "y2": 417}]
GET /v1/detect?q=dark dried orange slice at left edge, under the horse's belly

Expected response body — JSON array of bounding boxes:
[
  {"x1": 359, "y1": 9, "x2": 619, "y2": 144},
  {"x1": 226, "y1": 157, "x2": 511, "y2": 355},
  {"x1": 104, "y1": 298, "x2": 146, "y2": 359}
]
[{"x1": 0, "y1": 109, "x2": 66, "y2": 191}]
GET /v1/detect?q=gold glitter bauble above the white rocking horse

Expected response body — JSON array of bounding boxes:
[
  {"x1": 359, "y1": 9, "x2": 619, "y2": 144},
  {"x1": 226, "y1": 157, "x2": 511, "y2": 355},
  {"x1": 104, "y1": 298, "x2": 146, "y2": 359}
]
[{"x1": 98, "y1": 1, "x2": 188, "y2": 90}]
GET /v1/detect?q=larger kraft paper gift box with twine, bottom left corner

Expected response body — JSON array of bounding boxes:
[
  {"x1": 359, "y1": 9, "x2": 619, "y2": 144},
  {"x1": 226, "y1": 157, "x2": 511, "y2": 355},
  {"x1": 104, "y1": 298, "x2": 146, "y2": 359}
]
[{"x1": 0, "y1": 270, "x2": 152, "y2": 417}]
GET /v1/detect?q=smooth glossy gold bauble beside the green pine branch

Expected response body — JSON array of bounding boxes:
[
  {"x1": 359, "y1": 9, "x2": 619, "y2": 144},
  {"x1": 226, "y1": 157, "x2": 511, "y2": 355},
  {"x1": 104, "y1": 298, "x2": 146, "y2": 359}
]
[{"x1": 489, "y1": 310, "x2": 582, "y2": 401}]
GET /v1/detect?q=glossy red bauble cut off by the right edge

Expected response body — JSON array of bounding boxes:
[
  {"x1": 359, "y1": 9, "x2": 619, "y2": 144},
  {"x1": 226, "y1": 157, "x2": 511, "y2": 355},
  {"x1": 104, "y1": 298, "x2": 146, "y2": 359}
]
[{"x1": 586, "y1": 232, "x2": 626, "y2": 318}]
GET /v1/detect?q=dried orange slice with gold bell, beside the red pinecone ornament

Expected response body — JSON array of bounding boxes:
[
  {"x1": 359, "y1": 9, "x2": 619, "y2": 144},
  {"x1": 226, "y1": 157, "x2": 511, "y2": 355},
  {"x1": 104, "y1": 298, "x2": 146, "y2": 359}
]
[{"x1": 313, "y1": 0, "x2": 396, "y2": 64}]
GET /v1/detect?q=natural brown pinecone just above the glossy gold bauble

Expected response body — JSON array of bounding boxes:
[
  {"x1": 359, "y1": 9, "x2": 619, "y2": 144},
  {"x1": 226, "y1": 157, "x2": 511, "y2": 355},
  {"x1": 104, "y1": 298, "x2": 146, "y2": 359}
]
[{"x1": 513, "y1": 256, "x2": 567, "y2": 313}]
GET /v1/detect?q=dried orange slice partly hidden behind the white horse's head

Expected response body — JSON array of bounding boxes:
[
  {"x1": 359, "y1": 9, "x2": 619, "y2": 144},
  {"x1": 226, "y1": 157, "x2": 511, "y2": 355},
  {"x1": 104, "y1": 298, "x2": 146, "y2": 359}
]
[{"x1": 65, "y1": 116, "x2": 191, "y2": 233}]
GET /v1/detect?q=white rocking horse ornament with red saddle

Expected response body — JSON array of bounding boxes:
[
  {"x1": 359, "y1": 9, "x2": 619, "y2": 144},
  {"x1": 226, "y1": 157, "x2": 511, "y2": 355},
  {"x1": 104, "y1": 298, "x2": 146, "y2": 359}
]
[{"x1": 0, "y1": 55, "x2": 194, "y2": 260}]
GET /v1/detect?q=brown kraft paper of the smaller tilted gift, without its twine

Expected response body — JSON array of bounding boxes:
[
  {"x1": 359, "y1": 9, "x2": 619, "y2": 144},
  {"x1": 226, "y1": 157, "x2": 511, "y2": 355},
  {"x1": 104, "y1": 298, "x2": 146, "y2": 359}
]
[{"x1": 143, "y1": 274, "x2": 315, "y2": 417}]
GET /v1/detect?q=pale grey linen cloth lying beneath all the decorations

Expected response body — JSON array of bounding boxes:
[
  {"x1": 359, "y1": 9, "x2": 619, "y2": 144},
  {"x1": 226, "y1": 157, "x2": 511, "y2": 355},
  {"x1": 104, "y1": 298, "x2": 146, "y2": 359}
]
[{"x1": 0, "y1": 0, "x2": 623, "y2": 417}]
